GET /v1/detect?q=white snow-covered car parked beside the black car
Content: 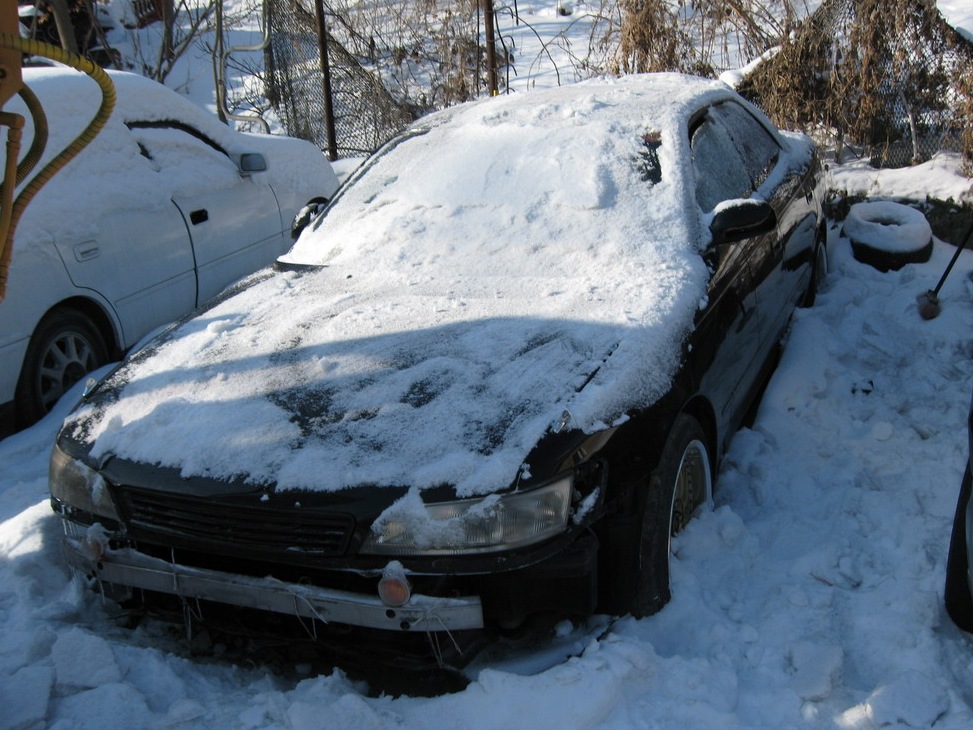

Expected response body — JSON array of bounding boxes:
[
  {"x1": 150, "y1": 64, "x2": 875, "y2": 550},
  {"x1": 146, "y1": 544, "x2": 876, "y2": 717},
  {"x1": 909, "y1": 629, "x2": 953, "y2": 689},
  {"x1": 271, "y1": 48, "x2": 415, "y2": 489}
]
[{"x1": 0, "y1": 68, "x2": 338, "y2": 426}]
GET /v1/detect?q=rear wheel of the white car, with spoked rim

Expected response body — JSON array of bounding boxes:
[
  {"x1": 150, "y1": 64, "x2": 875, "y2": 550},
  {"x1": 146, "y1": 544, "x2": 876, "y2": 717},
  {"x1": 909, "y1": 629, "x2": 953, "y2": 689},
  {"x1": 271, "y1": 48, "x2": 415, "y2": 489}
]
[{"x1": 14, "y1": 309, "x2": 108, "y2": 427}]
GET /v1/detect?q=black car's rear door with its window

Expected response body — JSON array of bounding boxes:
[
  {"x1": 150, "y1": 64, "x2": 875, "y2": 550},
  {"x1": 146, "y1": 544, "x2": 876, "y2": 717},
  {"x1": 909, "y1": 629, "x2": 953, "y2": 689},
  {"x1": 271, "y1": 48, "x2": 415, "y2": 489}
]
[{"x1": 712, "y1": 102, "x2": 817, "y2": 347}]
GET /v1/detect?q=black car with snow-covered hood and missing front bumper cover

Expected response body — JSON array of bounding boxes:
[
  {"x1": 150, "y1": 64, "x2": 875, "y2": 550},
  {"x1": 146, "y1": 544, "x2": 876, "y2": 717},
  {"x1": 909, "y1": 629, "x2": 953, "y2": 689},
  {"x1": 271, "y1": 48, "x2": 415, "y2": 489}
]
[{"x1": 50, "y1": 75, "x2": 827, "y2": 662}]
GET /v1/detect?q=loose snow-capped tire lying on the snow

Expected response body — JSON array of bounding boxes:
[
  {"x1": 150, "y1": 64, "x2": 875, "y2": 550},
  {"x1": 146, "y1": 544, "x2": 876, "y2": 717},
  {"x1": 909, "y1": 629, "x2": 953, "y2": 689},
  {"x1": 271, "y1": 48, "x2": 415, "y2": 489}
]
[{"x1": 842, "y1": 200, "x2": 932, "y2": 271}]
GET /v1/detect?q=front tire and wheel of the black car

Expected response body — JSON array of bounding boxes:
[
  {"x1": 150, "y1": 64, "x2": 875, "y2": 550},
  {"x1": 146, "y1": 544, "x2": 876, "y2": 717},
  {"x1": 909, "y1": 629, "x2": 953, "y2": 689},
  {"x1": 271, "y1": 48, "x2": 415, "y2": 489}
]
[{"x1": 633, "y1": 414, "x2": 713, "y2": 617}]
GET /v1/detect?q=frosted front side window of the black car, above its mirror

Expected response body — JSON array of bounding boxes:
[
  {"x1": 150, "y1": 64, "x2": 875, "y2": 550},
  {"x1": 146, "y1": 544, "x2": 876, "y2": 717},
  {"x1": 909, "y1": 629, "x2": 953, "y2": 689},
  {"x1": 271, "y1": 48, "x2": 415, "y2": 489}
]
[{"x1": 690, "y1": 112, "x2": 753, "y2": 211}]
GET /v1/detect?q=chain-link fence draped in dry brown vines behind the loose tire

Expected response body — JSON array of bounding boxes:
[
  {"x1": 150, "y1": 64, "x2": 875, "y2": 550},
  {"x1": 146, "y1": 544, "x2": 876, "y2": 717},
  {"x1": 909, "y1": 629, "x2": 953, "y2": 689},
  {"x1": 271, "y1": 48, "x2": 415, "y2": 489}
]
[{"x1": 741, "y1": 0, "x2": 973, "y2": 167}]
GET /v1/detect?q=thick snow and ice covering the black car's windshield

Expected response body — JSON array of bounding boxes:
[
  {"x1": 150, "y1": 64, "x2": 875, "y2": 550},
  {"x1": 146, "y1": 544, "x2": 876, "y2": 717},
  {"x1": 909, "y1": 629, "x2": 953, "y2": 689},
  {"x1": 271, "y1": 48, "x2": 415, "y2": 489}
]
[{"x1": 284, "y1": 82, "x2": 693, "y2": 275}]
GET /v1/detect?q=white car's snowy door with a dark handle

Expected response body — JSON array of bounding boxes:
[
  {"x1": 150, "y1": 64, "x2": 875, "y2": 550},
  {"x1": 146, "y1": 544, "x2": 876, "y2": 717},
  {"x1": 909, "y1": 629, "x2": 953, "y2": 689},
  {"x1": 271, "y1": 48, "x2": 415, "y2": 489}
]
[{"x1": 130, "y1": 123, "x2": 289, "y2": 304}]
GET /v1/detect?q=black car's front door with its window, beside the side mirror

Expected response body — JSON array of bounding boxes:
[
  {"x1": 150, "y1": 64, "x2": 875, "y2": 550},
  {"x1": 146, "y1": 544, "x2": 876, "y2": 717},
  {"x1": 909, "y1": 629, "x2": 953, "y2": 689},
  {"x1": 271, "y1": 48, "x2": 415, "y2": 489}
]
[{"x1": 690, "y1": 110, "x2": 769, "y2": 430}]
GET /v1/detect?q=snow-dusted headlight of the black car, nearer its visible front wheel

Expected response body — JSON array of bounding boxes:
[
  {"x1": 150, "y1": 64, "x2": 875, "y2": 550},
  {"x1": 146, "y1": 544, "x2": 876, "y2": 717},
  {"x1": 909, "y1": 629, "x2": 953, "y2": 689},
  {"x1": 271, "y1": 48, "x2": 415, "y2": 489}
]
[{"x1": 360, "y1": 477, "x2": 572, "y2": 555}]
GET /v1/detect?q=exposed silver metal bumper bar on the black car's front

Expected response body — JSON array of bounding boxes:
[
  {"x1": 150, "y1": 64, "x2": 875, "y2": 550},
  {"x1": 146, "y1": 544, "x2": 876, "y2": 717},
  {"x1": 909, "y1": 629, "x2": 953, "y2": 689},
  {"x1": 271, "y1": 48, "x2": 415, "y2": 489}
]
[{"x1": 64, "y1": 536, "x2": 483, "y2": 632}]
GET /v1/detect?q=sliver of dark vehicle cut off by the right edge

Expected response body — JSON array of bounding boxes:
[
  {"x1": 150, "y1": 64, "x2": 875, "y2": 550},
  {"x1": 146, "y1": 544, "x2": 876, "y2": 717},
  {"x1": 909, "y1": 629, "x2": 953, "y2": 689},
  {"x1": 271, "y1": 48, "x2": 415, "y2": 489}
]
[{"x1": 945, "y1": 390, "x2": 973, "y2": 632}]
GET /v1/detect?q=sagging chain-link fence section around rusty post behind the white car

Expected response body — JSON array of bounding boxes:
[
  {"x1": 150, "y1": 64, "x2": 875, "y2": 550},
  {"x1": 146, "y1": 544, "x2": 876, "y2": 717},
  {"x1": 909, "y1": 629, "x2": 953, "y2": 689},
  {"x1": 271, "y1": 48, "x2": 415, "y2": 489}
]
[{"x1": 265, "y1": 0, "x2": 414, "y2": 157}]
